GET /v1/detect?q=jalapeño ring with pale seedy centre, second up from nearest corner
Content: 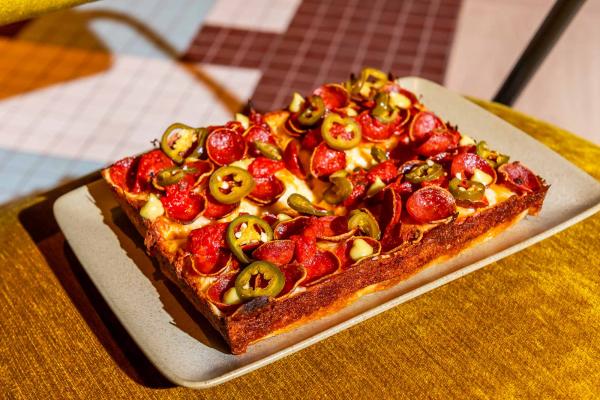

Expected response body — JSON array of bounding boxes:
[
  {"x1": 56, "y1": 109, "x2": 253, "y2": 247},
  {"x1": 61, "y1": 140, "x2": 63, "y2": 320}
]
[{"x1": 225, "y1": 215, "x2": 273, "y2": 264}]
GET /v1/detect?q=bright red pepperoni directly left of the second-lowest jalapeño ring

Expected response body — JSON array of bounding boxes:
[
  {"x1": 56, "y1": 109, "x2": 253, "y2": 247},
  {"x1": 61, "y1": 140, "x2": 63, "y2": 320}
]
[{"x1": 185, "y1": 223, "x2": 231, "y2": 274}]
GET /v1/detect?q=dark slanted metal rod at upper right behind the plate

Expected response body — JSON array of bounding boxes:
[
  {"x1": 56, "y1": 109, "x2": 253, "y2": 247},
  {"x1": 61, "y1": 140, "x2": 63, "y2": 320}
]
[{"x1": 494, "y1": 0, "x2": 585, "y2": 106}]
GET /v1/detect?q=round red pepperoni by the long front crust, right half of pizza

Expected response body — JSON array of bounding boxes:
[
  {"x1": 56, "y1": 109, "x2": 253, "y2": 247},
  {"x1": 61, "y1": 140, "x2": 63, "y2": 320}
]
[{"x1": 406, "y1": 186, "x2": 456, "y2": 224}]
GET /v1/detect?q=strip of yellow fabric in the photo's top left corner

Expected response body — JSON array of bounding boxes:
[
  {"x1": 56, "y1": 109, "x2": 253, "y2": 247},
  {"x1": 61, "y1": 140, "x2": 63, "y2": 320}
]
[{"x1": 0, "y1": 0, "x2": 93, "y2": 25}]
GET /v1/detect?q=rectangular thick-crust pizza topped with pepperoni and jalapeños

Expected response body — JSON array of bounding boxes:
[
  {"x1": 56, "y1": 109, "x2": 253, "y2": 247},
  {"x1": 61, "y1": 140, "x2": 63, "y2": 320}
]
[{"x1": 102, "y1": 68, "x2": 549, "y2": 354}]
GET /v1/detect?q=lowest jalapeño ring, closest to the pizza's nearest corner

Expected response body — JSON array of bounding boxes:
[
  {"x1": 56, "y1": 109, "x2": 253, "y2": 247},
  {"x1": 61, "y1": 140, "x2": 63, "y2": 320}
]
[{"x1": 235, "y1": 261, "x2": 285, "y2": 300}]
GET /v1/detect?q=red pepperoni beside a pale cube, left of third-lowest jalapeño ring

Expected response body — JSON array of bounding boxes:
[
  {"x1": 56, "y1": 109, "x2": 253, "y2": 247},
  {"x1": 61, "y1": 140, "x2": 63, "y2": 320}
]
[{"x1": 160, "y1": 175, "x2": 204, "y2": 222}]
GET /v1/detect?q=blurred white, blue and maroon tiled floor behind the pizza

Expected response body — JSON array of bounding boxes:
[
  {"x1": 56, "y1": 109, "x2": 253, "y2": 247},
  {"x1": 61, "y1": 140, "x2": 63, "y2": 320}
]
[{"x1": 0, "y1": 0, "x2": 460, "y2": 202}]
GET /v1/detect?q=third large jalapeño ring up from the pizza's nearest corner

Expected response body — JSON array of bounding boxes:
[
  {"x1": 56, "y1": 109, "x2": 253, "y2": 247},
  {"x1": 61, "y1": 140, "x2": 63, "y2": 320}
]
[{"x1": 208, "y1": 165, "x2": 254, "y2": 204}]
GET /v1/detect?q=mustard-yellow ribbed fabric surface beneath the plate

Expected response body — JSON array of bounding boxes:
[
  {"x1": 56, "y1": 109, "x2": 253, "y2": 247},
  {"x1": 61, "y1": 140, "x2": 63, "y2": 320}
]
[{"x1": 0, "y1": 102, "x2": 600, "y2": 399}]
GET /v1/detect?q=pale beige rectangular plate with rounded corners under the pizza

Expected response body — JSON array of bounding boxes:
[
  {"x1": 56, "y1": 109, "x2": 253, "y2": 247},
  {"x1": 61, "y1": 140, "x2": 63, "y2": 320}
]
[{"x1": 54, "y1": 77, "x2": 600, "y2": 389}]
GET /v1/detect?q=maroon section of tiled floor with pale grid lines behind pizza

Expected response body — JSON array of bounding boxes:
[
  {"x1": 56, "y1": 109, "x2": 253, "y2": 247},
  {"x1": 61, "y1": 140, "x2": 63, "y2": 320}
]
[{"x1": 180, "y1": 0, "x2": 461, "y2": 110}]
